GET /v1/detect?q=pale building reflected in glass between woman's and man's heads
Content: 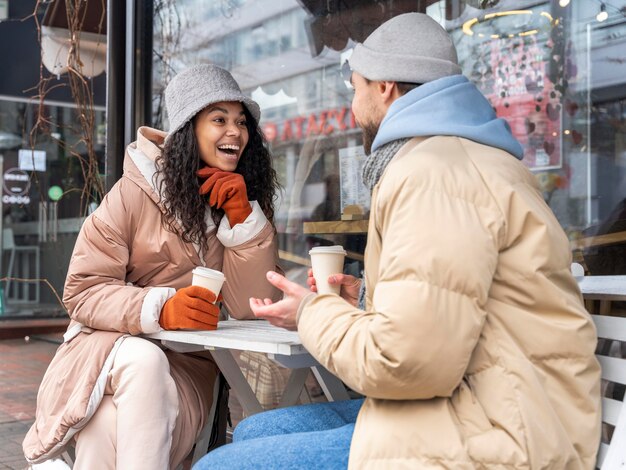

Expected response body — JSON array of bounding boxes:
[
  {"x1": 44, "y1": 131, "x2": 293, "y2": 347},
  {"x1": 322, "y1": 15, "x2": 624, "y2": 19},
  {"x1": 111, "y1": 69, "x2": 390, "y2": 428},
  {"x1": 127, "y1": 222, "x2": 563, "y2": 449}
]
[{"x1": 153, "y1": 0, "x2": 366, "y2": 235}]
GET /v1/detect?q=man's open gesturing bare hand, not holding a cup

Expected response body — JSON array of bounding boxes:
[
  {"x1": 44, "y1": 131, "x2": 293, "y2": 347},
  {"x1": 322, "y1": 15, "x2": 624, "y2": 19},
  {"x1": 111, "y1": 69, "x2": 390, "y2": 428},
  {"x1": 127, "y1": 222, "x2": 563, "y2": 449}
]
[{"x1": 250, "y1": 271, "x2": 309, "y2": 331}]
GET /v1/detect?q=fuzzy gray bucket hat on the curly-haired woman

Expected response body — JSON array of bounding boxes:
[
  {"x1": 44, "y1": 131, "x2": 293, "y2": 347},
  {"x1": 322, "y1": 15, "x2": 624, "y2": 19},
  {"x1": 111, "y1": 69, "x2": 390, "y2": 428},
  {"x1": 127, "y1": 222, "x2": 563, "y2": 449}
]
[{"x1": 165, "y1": 64, "x2": 261, "y2": 141}]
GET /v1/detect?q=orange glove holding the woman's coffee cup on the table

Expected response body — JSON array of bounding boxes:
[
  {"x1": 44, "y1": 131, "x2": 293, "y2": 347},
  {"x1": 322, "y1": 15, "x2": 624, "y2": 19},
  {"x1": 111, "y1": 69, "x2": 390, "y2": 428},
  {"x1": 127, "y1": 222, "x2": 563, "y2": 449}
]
[{"x1": 159, "y1": 286, "x2": 220, "y2": 330}]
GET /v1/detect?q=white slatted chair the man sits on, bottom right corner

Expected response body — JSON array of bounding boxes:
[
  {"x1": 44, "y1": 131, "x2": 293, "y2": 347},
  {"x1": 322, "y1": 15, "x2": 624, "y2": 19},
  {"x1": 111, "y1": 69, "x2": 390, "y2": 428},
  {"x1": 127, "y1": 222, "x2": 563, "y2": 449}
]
[{"x1": 591, "y1": 315, "x2": 626, "y2": 470}]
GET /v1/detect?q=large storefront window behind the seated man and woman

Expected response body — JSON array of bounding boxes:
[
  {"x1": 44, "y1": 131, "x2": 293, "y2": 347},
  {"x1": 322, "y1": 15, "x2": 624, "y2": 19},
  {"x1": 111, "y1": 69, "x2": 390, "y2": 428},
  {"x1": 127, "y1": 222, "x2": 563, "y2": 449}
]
[{"x1": 153, "y1": 0, "x2": 626, "y2": 282}]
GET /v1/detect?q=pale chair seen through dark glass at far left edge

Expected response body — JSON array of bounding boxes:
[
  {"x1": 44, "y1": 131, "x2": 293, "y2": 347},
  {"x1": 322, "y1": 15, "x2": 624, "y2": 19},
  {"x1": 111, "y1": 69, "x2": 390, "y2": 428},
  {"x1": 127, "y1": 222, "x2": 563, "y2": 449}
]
[{"x1": 2, "y1": 228, "x2": 40, "y2": 303}]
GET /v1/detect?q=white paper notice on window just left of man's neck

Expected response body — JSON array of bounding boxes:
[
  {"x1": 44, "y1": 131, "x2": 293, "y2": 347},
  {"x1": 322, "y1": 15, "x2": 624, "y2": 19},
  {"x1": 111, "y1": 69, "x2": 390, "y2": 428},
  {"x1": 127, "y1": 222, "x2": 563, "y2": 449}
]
[{"x1": 339, "y1": 145, "x2": 370, "y2": 213}]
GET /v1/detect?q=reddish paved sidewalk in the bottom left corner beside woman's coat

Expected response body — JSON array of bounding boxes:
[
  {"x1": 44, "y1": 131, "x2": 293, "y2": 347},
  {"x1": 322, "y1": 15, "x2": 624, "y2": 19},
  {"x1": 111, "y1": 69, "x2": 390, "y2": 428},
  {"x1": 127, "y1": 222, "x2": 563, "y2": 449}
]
[{"x1": 0, "y1": 333, "x2": 62, "y2": 470}]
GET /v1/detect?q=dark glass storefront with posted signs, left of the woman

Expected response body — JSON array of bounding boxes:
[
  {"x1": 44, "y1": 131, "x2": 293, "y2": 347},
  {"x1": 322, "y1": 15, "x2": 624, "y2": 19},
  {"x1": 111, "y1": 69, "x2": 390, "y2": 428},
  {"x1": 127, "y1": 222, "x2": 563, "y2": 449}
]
[{"x1": 0, "y1": 99, "x2": 104, "y2": 310}]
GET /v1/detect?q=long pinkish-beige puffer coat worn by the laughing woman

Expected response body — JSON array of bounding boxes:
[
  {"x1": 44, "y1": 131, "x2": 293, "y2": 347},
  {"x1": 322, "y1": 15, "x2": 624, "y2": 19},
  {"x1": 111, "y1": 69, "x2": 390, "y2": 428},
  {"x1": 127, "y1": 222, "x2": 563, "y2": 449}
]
[{"x1": 23, "y1": 127, "x2": 282, "y2": 463}]
